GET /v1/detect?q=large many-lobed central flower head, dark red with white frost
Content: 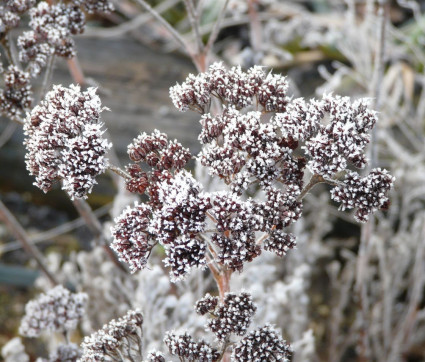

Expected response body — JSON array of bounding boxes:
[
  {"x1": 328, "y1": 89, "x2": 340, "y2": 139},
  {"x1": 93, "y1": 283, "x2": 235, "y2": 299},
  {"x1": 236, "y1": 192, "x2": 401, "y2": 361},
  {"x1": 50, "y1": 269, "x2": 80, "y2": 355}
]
[{"x1": 112, "y1": 63, "x2": 393, "y2": 281}]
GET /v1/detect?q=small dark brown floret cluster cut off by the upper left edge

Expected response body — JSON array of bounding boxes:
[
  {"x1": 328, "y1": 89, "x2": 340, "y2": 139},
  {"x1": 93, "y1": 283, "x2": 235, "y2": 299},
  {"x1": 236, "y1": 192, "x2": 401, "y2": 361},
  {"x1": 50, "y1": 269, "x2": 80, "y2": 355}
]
[{"x1": 0, "y1": 65, "x2": 32, "y2": 119}]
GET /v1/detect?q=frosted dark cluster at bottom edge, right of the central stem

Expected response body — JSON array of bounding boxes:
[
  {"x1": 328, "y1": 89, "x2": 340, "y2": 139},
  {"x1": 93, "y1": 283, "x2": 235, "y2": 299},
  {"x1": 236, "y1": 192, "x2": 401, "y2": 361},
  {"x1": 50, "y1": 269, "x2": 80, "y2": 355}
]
[{"x1": 232, "y1": 324, "x2": 292, "y2": 362}]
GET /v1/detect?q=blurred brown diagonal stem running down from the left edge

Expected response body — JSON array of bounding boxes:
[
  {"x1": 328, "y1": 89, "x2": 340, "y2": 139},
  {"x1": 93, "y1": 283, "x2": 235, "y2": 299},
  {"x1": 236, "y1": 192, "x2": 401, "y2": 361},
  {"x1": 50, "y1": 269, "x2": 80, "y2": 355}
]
[{"x1": 0, "y1": 200, "x2": 59, "y2": 285}]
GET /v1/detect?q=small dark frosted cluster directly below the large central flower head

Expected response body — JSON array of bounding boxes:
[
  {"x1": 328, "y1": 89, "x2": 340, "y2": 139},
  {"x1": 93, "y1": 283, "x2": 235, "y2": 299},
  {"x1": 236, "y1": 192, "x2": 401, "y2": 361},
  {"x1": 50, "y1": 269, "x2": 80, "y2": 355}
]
[{"x1": 207, "y1": 292, "x2": 257, "y2": 341}]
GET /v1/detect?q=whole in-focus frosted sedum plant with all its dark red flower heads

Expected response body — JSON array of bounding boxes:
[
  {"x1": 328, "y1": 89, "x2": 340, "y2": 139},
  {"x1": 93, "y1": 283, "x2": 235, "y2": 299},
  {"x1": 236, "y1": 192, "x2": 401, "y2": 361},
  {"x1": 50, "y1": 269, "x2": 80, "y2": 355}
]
[{"x1": 19, "y1": 63, "x2": 394, "y2": 362}]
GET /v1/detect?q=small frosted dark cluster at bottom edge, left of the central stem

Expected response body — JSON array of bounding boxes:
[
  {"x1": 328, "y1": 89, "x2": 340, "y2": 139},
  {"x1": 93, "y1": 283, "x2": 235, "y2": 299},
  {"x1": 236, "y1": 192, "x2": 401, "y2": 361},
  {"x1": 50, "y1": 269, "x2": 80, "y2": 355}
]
[{"x1": 164, "y1": 332, "x2": 220, "y2": 362}]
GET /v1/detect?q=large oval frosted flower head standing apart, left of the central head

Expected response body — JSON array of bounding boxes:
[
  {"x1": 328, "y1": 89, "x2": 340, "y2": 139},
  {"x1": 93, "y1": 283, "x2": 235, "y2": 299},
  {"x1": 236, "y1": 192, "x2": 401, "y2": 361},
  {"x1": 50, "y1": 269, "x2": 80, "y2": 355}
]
[{"x1": 24, "y1": 85, "x2": 111, "y2": 199}]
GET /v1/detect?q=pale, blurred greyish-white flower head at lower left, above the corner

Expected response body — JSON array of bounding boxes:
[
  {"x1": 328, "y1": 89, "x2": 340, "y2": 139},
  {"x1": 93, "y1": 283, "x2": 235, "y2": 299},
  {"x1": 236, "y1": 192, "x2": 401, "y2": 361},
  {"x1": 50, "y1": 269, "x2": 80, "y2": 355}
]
[{"x1": 19, "y1": 285, "x2": 88, "y2": 337}]
